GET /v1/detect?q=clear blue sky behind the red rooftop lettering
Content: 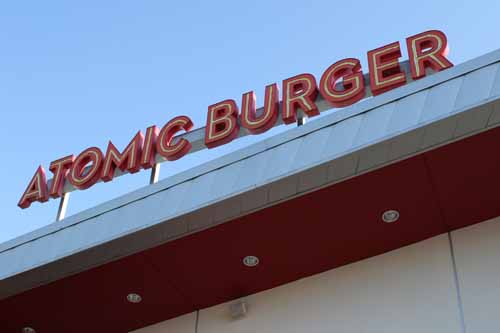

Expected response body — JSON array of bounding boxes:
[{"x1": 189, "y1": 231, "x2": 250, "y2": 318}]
[{"x1": 0, "y1": 0, "x2": 500, "y2": 242}]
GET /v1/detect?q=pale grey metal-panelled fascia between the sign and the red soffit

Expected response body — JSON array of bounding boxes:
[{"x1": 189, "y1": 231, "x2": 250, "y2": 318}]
[{"x1": 0, "y1": 50, "x2": 500, "y2": 297}]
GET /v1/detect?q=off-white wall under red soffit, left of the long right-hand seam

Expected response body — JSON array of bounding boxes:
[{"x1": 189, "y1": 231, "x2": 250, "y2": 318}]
[{"x1": 132, "y1": 235, "x2": 462, "y2": 333}]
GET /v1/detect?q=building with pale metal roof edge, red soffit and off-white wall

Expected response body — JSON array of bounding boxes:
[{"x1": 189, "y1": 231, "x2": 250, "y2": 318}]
[{"x1": 0, "y1": 44, "x2": 500, "y2": 333}]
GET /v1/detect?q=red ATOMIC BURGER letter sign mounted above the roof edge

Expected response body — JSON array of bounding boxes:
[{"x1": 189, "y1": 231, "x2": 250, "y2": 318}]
[{"x1": 18, "y1": 30, "x2": 453, "y2": 208}]
